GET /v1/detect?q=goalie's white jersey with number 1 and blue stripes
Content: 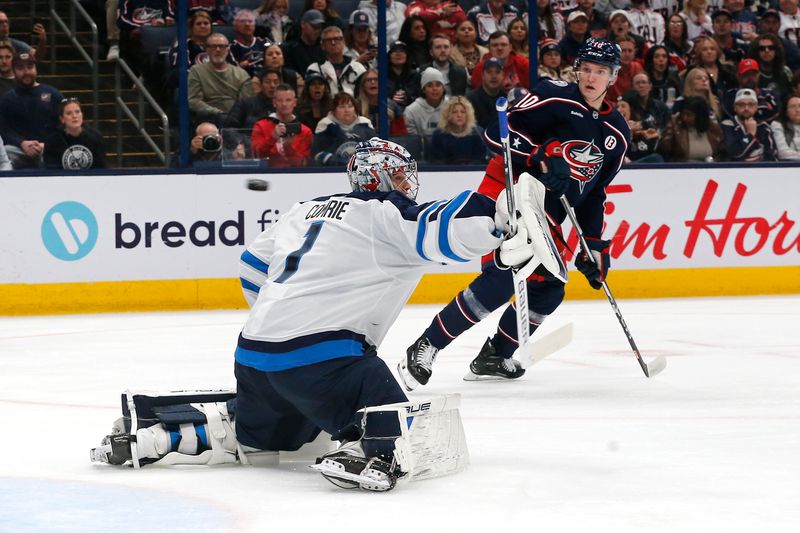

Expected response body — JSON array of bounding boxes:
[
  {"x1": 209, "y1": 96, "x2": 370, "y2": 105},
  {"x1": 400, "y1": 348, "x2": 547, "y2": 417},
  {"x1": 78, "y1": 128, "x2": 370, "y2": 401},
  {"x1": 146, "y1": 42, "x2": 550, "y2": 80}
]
[{"x1": 236, "y1": 191, "x2": 501, "y2": 371}]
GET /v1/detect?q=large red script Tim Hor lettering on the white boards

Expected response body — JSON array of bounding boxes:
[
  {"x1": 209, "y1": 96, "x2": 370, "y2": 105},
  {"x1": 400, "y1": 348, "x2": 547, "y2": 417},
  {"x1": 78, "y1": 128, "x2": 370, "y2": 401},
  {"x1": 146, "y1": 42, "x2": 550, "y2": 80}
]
[{"x1": 565, "y1": 180, "x2": 800, "y2": 261}]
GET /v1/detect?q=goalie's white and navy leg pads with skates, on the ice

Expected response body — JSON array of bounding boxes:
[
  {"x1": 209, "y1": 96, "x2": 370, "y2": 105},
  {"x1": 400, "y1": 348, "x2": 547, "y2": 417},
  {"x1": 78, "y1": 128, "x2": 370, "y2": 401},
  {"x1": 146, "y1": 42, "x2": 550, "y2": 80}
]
[{"x1": 90, "y1": 390, "x2": 469, "y2": 491}]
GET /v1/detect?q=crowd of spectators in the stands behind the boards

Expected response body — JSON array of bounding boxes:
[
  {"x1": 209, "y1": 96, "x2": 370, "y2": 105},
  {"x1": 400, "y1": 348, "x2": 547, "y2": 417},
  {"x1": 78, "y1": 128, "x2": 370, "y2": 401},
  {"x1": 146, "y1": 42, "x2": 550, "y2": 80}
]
[{"x1": 0, "y1": 0, "x2": 800, "y2": 168}]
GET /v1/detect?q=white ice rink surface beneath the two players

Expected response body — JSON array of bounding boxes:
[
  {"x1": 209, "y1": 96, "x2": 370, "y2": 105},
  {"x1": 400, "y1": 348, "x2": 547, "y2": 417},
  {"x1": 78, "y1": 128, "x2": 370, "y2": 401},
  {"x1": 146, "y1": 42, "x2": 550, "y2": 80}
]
[{"x1": 0, "y1": 296, "x2": 800, "y2": 533}]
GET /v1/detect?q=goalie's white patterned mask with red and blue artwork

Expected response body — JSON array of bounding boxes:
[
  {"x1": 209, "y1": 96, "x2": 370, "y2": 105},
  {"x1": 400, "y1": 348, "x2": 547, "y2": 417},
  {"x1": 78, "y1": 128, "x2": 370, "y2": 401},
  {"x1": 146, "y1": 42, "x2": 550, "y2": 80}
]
[{"x1": 347, "y1": 137, "x2": 419, "y2": 200}]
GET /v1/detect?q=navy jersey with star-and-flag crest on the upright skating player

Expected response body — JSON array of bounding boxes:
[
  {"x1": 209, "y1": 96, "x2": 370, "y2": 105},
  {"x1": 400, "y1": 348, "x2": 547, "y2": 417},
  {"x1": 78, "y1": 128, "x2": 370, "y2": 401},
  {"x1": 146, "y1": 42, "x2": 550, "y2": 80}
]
[{"x1": 481, "y1": 80, "x2": 631, "y2": 237}]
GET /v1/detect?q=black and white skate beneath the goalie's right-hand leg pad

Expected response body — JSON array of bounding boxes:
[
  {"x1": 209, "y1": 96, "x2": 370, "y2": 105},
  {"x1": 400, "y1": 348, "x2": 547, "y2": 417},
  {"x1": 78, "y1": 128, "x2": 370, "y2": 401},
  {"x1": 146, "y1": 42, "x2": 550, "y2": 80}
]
[{"x1": 309, "y1": 449, "x2": 404, "y2": 492}]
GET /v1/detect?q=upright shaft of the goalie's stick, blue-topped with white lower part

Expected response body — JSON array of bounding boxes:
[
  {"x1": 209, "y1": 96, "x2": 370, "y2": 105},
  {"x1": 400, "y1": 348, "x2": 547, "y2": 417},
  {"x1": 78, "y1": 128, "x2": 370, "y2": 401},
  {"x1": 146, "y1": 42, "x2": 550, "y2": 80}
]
[{"x1": 495, "y1": 97, "x2": 531, "y2": 353}]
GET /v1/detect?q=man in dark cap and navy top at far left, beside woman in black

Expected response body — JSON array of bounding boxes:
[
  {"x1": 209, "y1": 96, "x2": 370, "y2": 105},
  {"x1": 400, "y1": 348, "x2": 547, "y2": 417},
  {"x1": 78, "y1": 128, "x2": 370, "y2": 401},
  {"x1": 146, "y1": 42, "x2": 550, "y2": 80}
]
[{"x1": 0, "y1": 52, "x2": 64, "y2": 168}]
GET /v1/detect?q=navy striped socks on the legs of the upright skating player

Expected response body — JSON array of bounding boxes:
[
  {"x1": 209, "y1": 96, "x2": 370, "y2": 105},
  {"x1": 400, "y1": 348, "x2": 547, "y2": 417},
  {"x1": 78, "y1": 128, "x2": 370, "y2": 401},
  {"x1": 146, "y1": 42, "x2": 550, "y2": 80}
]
[{"x1": 425, "y1": 262, "x2": 564, "y2": 357}]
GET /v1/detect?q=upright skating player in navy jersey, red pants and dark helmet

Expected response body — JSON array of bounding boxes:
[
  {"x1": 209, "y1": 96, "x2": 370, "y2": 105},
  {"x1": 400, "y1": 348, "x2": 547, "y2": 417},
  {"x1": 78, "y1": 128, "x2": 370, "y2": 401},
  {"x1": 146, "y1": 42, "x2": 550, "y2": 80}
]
[{"x1": 398, "y1": 39, "x2": 630, "y2": 390}]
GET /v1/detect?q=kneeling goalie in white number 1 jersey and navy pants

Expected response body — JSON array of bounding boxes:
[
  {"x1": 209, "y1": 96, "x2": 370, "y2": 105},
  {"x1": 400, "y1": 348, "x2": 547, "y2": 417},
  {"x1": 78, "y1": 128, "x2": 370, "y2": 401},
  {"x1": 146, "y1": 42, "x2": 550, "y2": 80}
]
[{"x1": 92, "y1": 138, "x2": 544, "y2": 491}]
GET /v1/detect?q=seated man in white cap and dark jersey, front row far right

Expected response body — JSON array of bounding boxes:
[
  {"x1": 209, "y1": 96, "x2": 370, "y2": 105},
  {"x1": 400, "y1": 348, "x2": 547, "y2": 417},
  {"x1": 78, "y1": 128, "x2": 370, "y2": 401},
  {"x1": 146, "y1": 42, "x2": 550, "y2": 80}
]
[{"x1": 720, "y1": 89, "x2": 778, "y2": 163}]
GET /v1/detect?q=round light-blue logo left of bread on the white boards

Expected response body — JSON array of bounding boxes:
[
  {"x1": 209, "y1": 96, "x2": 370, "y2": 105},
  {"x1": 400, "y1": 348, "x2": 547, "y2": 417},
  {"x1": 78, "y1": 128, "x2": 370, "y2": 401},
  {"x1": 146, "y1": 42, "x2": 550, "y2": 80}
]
[{"x1": 42, "y1": 202, "x2": 97, "y2": 261}]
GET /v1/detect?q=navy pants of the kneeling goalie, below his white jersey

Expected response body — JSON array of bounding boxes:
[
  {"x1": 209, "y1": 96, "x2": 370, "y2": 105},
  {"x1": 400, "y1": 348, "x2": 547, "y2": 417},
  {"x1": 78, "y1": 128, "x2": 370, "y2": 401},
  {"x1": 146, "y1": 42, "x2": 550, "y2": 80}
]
[{"x1": 234, "y1": 355, "x2": 408, "y2": 451}]
